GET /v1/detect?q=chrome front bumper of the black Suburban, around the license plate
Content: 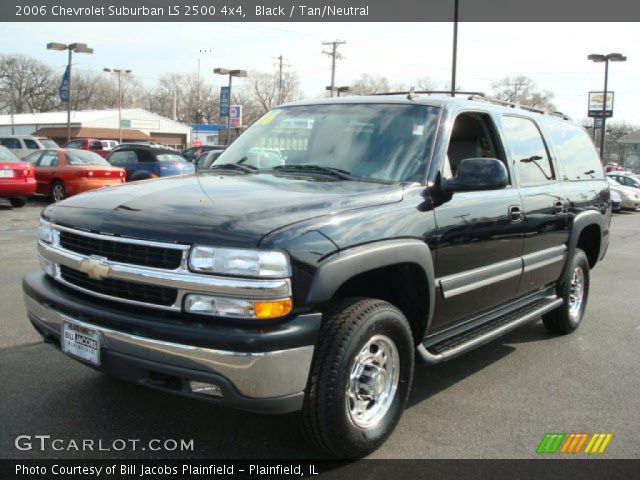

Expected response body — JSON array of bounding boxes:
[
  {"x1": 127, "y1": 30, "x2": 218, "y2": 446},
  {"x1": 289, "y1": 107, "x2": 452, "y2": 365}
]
[{"x1": 24, "y1": 294, "x2": 314, "y2": 398}]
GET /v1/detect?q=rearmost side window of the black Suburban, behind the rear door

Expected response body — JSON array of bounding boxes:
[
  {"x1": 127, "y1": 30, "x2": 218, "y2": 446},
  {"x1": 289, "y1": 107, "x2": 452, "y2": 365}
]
[{"x1": 548, "y1": 121, "x2": 604, "y2": 180}]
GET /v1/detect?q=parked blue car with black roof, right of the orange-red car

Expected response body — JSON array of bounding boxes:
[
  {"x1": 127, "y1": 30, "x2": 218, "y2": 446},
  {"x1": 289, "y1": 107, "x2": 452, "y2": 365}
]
[{"x1": 107, "y1": 144, "x2": 195, "y2": 182}]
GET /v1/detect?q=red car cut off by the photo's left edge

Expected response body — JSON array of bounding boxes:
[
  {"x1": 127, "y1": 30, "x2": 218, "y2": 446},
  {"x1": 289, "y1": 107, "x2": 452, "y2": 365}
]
[{"x1": 0, "y1": 146, "x2": 36, "y2": 207}]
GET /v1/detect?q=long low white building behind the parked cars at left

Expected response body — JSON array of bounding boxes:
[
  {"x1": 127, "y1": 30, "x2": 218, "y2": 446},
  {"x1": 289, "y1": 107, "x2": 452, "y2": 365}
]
[{"x1": 0, "y1": 108, "x2": 191, "y2": 150}]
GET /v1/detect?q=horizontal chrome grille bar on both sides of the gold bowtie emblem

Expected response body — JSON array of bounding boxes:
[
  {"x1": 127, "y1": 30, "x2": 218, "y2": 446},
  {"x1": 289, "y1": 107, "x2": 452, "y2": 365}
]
[{"x1": 38, "y1": 241, "x2": 291, "y2": 309}]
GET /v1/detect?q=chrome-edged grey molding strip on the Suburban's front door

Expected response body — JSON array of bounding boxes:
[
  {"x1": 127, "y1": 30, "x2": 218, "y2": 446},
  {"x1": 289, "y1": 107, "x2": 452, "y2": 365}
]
[{"x1": 436, "y1": 258, "x2": 522, "y2": 298}]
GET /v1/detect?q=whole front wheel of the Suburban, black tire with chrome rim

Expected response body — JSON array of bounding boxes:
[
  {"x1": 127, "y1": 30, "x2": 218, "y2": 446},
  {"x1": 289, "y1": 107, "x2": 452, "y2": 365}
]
[{"x1": 302, "y1": 298, "x2": 415, "y2": 458}]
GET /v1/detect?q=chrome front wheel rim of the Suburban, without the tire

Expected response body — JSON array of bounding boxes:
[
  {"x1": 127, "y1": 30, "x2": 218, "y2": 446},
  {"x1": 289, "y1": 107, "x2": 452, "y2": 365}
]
[{"x1": 346, "y1": 335, "x2": 400, "y2": 429}]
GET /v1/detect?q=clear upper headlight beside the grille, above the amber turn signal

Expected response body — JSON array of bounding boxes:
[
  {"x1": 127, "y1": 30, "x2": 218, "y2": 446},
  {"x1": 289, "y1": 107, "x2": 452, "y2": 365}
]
[{"x1": 189, "y1": 245, "x2": 291, "y2": 278}]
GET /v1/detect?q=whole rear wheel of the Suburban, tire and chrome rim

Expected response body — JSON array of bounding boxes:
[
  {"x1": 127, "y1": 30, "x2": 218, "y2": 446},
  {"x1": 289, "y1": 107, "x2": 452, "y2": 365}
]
[{"x1": 542, "y1": 249, "x2": 589, "y2": 335}]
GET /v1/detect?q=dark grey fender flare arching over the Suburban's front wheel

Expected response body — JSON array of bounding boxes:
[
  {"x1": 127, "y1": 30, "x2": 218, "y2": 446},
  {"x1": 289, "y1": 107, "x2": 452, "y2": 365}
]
[{"x1": 307, "y1": 239, "x2": 435, "y2": 321}]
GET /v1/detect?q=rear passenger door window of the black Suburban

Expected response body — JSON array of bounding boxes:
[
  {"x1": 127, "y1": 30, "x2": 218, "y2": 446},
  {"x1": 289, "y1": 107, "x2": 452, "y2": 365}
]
[{"x1": 502, "y1": 116, "x2": 554, "y2": 185}]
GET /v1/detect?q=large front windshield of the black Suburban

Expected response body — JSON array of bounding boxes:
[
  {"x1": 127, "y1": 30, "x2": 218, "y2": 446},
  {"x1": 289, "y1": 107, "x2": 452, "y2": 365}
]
[{"x1": 215, "y1": 104, "x2": 439, "y2": 182}]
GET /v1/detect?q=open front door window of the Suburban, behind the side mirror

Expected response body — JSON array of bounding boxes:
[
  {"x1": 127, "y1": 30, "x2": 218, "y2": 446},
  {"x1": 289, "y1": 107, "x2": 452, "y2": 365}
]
[{"x1": 443, "y1": 112, "x2": 507, "y2": 178}]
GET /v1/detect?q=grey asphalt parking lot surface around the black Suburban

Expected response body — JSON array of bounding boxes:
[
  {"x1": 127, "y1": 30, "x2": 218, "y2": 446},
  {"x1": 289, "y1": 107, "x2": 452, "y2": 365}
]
[{"x1": 0, "y1": 200, "x2": 640, "y2": 458}]
